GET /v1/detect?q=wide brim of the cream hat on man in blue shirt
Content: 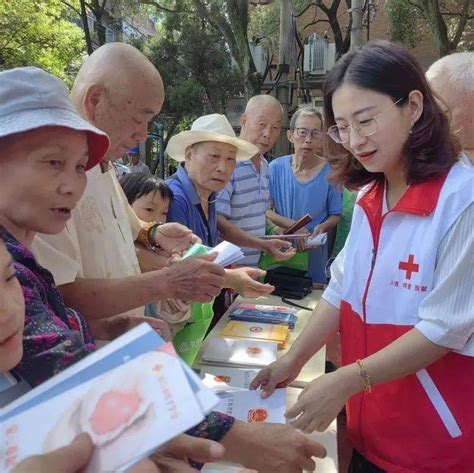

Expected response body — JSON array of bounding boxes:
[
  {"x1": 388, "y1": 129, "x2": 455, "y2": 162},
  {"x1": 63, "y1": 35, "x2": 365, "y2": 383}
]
[{"x1": 166, "y1": 130, "x2": 259, "y2": 162}]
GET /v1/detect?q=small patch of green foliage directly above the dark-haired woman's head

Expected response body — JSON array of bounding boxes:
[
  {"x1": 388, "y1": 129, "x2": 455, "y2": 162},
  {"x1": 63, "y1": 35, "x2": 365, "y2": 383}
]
[{"x1": 385, "y1": 0, "x2": 421, "y2": 48}]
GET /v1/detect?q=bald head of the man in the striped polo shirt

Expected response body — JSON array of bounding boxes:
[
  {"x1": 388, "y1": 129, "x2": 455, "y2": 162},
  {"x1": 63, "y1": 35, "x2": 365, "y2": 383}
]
[{"x1": 240, "y1": 95, "x2": 283, "y2": 154}]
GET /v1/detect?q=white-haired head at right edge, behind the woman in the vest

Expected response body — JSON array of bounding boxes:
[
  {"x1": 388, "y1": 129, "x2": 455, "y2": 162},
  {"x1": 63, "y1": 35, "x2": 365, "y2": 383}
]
[{"x1": 426, "y1": 52, "x2": 474, "y2": 152}]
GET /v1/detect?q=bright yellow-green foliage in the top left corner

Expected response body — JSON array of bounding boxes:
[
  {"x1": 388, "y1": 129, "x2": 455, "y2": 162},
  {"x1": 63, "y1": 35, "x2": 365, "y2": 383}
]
[{"x1": 0, "y1": 0, "x2": 84, "y2": 84}]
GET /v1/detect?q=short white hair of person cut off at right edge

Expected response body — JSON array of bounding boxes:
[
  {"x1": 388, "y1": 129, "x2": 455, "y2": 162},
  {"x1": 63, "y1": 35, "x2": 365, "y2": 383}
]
[{"x1": 426, "y1": 52, "x2": 474, "y2": 94}]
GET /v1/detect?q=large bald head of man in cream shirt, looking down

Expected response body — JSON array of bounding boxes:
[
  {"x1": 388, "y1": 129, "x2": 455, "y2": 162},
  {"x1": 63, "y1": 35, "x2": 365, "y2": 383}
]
[{"x1": 71, "y1": 43, "x2": 164, "y2": 160}]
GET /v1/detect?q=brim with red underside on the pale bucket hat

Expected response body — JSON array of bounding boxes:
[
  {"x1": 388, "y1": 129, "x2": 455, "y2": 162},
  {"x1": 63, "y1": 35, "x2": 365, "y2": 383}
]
[{"x1": 0, "y1": 108, "x2": 110, "y2": 169}]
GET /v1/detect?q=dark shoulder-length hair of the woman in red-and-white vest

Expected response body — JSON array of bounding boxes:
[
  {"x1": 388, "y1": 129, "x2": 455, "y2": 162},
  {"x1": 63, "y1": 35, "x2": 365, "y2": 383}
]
[{"x1": 323, "y1": 41, "x2": 460, "y2": 190}]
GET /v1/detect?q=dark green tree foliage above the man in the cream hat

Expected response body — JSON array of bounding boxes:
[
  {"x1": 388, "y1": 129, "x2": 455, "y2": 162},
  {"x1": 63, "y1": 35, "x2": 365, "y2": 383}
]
[{"x1": 143, "y1": 1, "x2": 241, "y2": 133}]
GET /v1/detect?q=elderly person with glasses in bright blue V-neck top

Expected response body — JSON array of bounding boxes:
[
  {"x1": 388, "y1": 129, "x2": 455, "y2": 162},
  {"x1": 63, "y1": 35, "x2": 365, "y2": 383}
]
[{"x1": 267, "y1": 108, "x2": 342, "y2": 283}]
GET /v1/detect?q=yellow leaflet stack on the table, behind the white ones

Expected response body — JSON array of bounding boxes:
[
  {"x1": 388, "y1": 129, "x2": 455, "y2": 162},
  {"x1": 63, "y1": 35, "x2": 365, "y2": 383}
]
[{"x1": 221, "y1": 320, "x2": 290, "y2": 348}]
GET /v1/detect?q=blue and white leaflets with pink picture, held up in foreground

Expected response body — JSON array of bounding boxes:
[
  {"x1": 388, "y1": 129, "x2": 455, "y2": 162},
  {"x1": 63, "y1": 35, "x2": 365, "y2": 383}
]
[{"x1": 0, "y1": 324, "x2": 219, "y2": 472}]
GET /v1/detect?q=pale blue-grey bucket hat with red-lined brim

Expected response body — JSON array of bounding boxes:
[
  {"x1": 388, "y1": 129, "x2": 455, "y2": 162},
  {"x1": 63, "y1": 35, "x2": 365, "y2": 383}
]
[{"x1": 0, "y1": 67, "x2": 109, "y2": 169}]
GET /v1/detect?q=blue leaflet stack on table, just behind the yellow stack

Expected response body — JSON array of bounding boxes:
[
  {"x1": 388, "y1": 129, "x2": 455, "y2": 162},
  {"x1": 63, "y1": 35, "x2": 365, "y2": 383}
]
[{"x1": 229, "y1": 302, "x2": 297, "y2": 329}]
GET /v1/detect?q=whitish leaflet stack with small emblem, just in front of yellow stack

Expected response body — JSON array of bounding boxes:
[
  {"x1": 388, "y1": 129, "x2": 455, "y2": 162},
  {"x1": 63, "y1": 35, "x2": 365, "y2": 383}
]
[{"x1": 202, "y1": 337, "x2": 277, "y2": 366}]
